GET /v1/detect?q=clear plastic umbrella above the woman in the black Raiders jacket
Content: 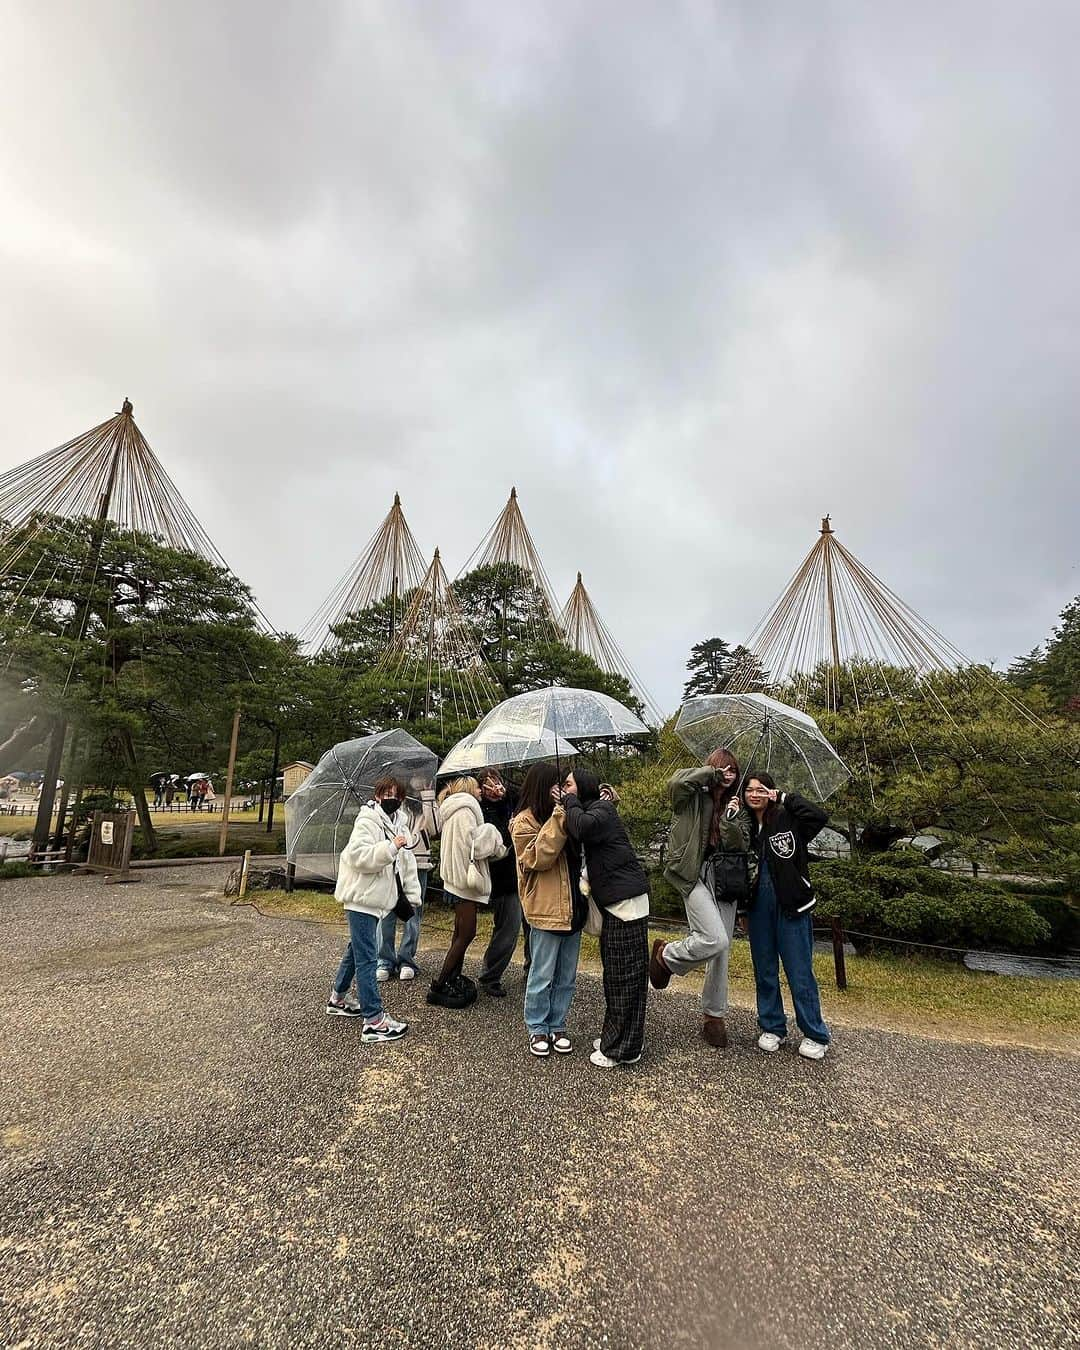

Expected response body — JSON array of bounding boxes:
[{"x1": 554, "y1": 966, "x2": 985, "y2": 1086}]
[{"x1": 675, "y1": 694, "x2": 852, "y2": 802}]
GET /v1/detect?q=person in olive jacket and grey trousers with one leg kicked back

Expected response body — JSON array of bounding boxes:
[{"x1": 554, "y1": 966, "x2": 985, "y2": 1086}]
[{"x1": 649, "y1": 749, "x2": 751, "y2": 1050}]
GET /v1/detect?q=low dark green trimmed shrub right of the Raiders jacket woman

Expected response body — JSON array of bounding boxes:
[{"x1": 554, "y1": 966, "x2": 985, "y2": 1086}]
[{"x1": 813, "y1": 852, "x2": 1054, "y2": 950}]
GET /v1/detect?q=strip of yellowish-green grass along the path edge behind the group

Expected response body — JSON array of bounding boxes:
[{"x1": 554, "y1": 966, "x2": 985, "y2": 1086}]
[{"x1": 225, "y1": 890, "x2": 1080, "y2": 1054}]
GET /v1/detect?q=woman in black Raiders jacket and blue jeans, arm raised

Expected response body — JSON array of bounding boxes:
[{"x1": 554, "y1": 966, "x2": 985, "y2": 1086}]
[{"x1": 743, "y1": 774, "x2": 832, "y2": 1060}]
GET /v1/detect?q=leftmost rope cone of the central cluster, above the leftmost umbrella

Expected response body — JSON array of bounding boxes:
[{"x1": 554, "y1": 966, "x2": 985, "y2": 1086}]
[{"x1": 301, "y1": 493, "x2": 425, "y2": 652}]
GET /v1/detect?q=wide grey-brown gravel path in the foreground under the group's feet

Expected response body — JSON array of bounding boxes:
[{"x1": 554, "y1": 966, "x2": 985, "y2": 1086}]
[{"x1": 0, "y1": 868, "x2": 1080, "y2": 1350}]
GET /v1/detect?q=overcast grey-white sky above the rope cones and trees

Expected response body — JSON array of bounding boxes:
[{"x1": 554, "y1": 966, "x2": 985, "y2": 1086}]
[{"x1": 0, "y1": 0, "x2": 1080, "y2": 706}]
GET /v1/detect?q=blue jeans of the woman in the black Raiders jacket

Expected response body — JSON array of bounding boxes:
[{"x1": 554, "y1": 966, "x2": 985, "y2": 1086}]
[{"x1": 747, "y1": 859, "x2": 830, "y2": 1045}]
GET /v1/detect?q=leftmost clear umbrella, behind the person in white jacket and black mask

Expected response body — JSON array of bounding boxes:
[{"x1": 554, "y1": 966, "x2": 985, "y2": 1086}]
[{"x1": 285, "y1": 730, "x2": 439, "y2": 882}]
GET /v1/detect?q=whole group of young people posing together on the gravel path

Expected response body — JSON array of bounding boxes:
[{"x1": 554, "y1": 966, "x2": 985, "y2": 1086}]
[{"x1": 327, "y1": 749, "x2": 830, "y2": 1069}]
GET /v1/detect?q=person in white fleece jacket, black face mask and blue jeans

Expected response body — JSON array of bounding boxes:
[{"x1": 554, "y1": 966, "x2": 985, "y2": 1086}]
[{"x1": 327, "y1": 778, "x2": 420, "y2": 1042}]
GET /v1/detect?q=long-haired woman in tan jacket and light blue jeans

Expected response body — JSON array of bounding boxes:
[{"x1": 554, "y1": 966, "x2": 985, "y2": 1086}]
[{"x1": 510, "y1": 764, "x2": 587, "y2": 1057}]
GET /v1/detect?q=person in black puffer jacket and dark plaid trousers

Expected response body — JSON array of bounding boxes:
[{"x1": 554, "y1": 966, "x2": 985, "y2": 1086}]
[{"x1": 563, "y1": 768, "x2": 649, "y2": 1069}]
